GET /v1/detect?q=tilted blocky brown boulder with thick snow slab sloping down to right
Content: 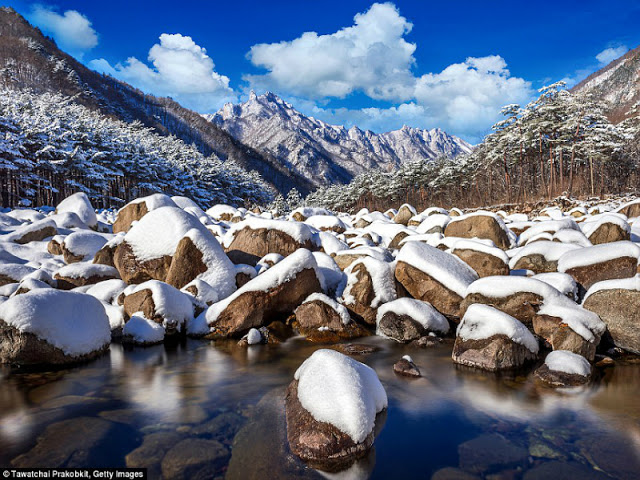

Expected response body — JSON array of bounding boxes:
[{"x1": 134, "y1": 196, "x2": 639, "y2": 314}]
[{"x1": 395, "y1": 242, "x2": 478, "y2": 318}]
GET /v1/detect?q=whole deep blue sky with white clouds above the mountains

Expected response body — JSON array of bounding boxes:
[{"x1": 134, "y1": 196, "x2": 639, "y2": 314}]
[{"x1": 8, "y1": 0, "x2": 640, "y2": 142}]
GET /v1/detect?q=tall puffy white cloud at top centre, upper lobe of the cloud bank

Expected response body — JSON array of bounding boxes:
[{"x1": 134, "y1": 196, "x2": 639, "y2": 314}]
[{"x1": 245, "y1": 3, "x2": 416, "y2": 100}]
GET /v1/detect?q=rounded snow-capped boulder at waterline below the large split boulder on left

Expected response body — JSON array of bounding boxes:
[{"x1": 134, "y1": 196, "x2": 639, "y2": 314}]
[{"x1": 124, "y1": 280, "x2": 194, "y2": 334}]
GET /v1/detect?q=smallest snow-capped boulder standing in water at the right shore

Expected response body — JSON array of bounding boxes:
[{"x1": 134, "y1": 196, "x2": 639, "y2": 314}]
[{"x1": 535, "y1": 350, "x2": 591, "y2": 387}]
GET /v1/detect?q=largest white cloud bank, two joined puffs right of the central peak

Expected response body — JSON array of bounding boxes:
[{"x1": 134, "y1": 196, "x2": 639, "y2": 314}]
[{"x1": 244, "y1": 3, "x2": 533, "y2": 141}]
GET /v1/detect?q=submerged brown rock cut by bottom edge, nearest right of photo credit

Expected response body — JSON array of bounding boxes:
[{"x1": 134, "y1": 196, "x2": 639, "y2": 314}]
[{"x1": 162, "y1": 438, "x2": 229, "y2": 480}]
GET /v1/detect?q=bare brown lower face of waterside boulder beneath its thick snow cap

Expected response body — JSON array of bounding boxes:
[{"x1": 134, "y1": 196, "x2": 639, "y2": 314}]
[{"x1": 451, "y1": 335, "x2": 537, "y2": 372}]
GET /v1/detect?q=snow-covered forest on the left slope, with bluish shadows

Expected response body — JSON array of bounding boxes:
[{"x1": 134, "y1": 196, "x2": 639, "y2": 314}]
[{"x1": 0, "y1": 89, "x2": 272, "y2": 207}]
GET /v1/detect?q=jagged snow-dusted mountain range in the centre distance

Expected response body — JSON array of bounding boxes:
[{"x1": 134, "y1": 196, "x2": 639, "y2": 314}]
[{"x1": 206, "y1": 92, "x2": 472, "y2": 185}]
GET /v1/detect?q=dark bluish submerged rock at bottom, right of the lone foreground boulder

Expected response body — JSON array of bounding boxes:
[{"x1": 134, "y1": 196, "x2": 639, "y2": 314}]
[{"x1": 458, "y1": 433, "x2": 529, "y2": 474}]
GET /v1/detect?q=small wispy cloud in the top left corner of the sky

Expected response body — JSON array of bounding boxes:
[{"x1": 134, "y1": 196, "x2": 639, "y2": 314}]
[{"x1": 27, "y1": 5, "x2": 98, "y2": 58}]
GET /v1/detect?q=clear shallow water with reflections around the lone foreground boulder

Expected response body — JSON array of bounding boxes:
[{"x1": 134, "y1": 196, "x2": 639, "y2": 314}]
[{"x1": 0, "y1": 337, "x2": 640, "y2": 479}]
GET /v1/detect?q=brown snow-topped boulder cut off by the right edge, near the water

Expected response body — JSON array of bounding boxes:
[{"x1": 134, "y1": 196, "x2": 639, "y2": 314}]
[{"x1": 582, "y1": 275, "x2": 640, "y2": 355}]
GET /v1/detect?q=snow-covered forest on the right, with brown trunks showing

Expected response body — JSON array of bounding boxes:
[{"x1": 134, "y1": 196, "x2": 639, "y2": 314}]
[{"x1": 306, "y1": 82, "x2": 640, "y2": 209}]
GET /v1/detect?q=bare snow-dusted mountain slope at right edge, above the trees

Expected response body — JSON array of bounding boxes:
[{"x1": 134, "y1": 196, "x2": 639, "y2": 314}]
[{"x1": 572, "y1": 43, "x2": 640, "y2": 123}]
